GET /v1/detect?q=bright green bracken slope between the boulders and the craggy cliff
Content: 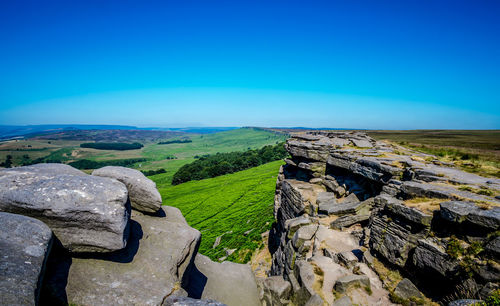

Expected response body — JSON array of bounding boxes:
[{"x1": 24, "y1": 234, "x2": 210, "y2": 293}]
[{"x1": 150, "y1": 161, "x2": 283, "y2": 262}]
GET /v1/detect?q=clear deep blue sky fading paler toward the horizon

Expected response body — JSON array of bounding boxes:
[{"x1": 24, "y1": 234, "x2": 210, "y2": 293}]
[{"x1": 0, "y1": 0, "x2": 500, "y2": 129}]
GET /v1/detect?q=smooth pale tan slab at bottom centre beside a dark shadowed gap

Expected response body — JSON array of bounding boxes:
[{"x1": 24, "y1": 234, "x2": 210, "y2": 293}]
[{"x1": 187, "y1": 254, "x2": 260, "y2": 306}]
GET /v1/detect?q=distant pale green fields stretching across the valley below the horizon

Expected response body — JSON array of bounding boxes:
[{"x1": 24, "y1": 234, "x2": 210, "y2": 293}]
[{"x1": 0, "y1": 128, "x2": 287, "y2": 182}]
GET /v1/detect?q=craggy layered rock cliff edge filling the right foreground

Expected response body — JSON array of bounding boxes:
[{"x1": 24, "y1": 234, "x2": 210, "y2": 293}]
[{"x1": 259, "y1": 132, "x2": 500, "y2": 305}]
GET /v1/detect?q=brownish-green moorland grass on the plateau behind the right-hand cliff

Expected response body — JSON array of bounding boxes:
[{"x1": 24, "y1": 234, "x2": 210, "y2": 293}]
[{"x1": 367, "y1": 130, "x2": 500, "y2": 178}]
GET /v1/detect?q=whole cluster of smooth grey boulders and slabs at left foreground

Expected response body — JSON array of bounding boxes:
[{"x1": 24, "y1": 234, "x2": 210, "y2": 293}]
[{"x1": 0, "y1": 164, "x2": 259, "y2": 306}]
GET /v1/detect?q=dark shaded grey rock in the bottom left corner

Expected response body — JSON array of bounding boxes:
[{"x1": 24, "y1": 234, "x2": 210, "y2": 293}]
[{"x1": 0, "y1": 212, "x2": 52, "y2": 305}]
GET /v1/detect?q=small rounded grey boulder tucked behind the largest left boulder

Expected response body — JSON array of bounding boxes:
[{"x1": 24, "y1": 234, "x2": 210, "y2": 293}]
[{"x1": 92, "y1": 166, "x2": 162, "y2": 213}]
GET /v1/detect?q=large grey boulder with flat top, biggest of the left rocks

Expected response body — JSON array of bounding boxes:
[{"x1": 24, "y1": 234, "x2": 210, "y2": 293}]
[{"x1": 0, "y1": 164, "x2": 130, "y2": 252}]
